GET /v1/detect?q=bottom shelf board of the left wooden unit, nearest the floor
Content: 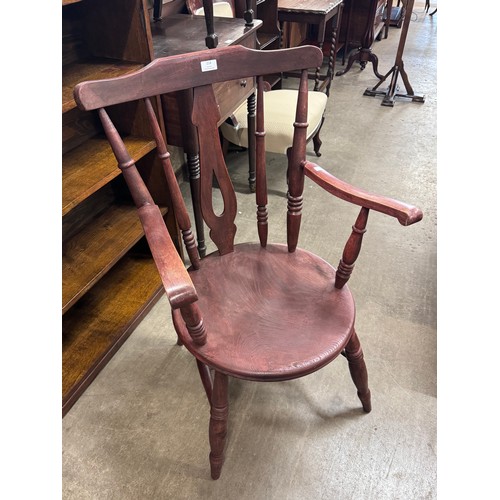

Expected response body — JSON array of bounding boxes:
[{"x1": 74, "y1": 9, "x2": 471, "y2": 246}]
[{"x1": 62, "y1": 256, "x2": 163, "y2": 413}]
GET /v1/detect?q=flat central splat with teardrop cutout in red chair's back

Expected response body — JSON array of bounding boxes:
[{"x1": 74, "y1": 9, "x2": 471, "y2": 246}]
[{"x1": 193, "y1": 85, "x2": 236, "y2": 255}]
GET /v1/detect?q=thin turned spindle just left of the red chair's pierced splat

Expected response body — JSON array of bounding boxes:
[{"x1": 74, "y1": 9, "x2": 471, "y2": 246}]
[{"x1": 144, "y1": 97, "x2": 200, "y2": 269}]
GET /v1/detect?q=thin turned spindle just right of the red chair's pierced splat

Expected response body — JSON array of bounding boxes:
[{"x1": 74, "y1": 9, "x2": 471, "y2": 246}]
[{"x1": 255, "y1": 76, "x2": 268, "y2": 247}]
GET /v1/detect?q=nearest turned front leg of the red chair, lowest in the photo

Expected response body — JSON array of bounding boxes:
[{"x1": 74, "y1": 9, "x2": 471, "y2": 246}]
[{"x1": 209, "y1": 371, "x2": 228, "y2": 479}]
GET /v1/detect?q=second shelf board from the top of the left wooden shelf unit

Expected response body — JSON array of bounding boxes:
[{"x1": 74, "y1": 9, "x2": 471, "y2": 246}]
[{"x1": 62, "y1": 137, "x2": 156, "y2": 216}]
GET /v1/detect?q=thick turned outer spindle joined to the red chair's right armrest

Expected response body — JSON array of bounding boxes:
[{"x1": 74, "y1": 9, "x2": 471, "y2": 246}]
[{"x1": 287, "y1": 70, "x2": 308, "y2": 252}]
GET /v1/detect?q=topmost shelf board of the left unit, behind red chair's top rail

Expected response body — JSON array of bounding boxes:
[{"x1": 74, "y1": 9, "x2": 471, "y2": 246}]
[{"x1": 62, "y1": 59, "x2": 144, "y2": 113}]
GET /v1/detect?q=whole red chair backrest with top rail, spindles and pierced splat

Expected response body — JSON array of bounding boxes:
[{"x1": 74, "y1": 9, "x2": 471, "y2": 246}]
[{"x1": 74, "y1": 45, "x2": 322, "y2": 258}]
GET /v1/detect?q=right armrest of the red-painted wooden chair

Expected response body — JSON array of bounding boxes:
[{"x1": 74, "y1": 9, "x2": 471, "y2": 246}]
[{"x1": 303, "y1": 161, "x2": 423, "y2": 226}]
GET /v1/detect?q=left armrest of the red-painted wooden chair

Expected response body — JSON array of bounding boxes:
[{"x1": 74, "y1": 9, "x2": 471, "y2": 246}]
[{"x1": 137, "y1": 205, "x2": 198, "y2": 309}]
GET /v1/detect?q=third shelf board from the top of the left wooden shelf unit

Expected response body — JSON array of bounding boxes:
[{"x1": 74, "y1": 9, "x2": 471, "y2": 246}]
[{"x1": 62, "y1": 205, "x2": 167, "y2": 314}]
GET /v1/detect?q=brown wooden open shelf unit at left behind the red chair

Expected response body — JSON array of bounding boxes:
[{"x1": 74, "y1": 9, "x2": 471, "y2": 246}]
[{"x1": 62, "y1": 0, "x2": 180, "y2": 415}]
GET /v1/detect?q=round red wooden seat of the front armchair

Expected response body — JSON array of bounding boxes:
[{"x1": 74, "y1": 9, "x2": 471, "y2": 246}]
[{"x1": 173, "y1": 243, "x2": 355, "y2": 380}]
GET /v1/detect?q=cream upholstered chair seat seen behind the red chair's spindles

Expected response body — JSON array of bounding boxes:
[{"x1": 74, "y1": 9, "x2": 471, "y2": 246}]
[{"x1": 220, "y1": 89, "x2": 328, "y2": 154}]
